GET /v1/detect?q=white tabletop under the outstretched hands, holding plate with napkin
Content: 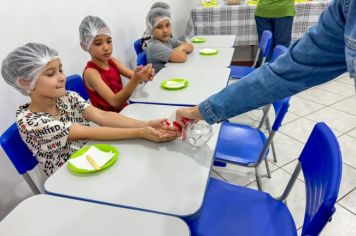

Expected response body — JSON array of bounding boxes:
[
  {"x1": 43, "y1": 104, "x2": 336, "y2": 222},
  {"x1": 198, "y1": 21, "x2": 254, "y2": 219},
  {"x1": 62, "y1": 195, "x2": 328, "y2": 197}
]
[{"x1": 45, "y1": 104, "x2": 220, "y2": 216}]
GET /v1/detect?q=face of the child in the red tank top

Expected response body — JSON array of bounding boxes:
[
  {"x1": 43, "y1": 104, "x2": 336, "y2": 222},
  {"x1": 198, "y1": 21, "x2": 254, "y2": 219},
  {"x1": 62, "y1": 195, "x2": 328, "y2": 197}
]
[{"x1": 89, "y1": 35, "x2": 112, "y2": 61}]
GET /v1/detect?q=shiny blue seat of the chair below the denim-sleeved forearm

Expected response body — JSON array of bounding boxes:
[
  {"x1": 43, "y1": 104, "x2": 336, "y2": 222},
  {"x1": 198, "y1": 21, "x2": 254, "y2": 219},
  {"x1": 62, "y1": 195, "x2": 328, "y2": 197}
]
[{"x1": 215, "y1": 122, "x2": 267, "y2": 165}]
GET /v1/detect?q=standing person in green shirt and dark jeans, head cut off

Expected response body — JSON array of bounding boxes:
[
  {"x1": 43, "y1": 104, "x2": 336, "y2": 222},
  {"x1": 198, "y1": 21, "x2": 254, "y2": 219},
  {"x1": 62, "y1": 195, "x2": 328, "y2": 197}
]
[{"x1": 255, "y1": 0, "x2": 295, "y2": 48}]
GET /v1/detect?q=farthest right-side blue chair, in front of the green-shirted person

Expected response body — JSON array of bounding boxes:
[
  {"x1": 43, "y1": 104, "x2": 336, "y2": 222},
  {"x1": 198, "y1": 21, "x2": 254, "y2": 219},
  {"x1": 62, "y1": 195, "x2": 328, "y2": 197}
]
[{"x1": 230, "y1": 30, "x2": 272, "y2": 79}]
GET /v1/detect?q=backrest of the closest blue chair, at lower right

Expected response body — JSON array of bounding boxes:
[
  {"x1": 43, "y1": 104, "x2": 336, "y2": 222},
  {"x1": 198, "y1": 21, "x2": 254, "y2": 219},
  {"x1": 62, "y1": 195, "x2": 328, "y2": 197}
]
[{"x1": 299, "y1": 122, "x2": 342, "y2": 235}]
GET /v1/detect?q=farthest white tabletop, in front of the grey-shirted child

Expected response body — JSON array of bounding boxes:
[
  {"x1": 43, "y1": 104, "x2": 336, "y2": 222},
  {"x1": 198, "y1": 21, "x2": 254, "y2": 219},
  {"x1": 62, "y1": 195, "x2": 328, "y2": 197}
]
[{"x1": 189, "y1": 35, "x2": 236, "y2": 48}]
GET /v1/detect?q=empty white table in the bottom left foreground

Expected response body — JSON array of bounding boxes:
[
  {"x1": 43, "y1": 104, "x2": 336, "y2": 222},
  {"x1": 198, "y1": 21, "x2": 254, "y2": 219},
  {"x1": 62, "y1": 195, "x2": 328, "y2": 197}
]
[{"x1": 0, "y1": 194, "x2": 190, "y2": 236}]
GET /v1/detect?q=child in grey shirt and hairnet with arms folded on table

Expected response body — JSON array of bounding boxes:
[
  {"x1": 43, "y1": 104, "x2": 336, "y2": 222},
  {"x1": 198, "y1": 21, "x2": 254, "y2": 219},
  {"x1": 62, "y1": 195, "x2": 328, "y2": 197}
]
[{"x1": 146, "y1": 8, "x2": 193, "y2": 72}]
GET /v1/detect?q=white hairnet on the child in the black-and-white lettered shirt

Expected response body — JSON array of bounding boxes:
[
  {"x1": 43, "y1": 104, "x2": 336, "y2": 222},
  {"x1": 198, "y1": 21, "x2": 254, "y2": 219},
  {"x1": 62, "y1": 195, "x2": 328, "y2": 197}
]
[{"x1": 1, "y1": 43, "x2": 59, "y2": 95}]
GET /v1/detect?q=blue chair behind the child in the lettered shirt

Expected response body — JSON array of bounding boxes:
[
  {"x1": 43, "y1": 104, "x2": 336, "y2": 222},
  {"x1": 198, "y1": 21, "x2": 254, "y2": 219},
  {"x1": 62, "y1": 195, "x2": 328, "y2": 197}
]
[{"x1": 0, "y1": 123, "x2": 41, "y2": 194}]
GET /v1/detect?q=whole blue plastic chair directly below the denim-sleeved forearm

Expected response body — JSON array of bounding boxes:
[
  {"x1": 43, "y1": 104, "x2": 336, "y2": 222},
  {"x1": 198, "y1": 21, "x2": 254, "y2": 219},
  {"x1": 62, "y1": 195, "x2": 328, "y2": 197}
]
[{"x1": 215, "y1": 97, "x2": 290, "y2": 190}]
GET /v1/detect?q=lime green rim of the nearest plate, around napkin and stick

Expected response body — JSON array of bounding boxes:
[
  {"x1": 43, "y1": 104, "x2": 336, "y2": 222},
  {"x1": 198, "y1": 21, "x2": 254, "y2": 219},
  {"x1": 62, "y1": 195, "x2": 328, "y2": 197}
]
[{"x1": 67, "y1": 143, "x2": 119, "y2": 173}]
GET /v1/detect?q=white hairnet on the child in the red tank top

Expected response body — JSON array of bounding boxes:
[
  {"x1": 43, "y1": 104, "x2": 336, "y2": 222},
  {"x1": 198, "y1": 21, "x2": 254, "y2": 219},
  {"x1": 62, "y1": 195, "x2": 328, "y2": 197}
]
[{"x1": 79, "y1": 16, "x2": 111, "y2": 51}]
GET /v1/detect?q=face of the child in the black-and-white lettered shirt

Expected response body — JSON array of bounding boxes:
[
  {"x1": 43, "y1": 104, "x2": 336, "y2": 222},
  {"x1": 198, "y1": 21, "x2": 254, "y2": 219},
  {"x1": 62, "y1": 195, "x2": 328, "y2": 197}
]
[{"x1": 32, "y1": 59, "x2": 66, "y2": 98}]
